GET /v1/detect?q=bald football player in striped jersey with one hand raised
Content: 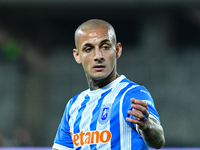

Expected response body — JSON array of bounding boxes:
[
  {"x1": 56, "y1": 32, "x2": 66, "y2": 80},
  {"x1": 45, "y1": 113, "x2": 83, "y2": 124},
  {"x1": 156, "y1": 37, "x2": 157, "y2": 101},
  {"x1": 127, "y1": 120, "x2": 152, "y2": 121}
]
[{"x1": 52, "y1": 19, "x2": 165, "y2": 150}]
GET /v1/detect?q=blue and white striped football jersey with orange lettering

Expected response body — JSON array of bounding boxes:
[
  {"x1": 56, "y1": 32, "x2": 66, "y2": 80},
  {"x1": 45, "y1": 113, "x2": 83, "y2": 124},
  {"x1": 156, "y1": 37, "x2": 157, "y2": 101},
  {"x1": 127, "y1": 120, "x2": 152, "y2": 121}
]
[{"x1": 53, "y1": 75, "x2": 160, "y2": 150}]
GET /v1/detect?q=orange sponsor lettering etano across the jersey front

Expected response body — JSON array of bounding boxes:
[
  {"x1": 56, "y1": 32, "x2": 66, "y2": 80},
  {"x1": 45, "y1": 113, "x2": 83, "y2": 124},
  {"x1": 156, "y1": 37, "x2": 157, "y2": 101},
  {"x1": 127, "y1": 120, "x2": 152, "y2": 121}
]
[{"x1": 71, "y1": 130, "x2": 112, "y2": 147}]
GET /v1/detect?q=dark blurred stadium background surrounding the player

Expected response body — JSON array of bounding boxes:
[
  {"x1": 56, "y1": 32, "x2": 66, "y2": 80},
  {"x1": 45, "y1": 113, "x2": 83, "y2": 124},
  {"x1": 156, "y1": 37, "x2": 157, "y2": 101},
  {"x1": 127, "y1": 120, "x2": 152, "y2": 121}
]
[{"x1": 0, "y1": 0, "x2": 200, "y2": 147}]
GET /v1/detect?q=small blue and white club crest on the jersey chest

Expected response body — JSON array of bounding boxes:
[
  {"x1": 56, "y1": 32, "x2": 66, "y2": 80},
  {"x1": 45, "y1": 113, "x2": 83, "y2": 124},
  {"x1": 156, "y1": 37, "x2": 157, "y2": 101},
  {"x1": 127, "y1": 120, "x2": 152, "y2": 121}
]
[{"x1": 98, "y1": 104, "x2": 111, "y2": 124}]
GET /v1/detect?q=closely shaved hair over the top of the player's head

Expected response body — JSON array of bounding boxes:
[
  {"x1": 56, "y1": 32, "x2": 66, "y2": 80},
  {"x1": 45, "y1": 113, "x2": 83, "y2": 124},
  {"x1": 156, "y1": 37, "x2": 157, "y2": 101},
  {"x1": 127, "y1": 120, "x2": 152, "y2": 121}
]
[{"x1": 74, "y1": 19, "x2": 116, "y2": 47}]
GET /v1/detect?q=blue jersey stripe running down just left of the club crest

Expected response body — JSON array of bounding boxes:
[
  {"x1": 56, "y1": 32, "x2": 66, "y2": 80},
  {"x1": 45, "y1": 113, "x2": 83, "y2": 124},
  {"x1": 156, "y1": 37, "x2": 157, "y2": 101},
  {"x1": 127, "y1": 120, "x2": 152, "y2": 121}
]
[{"x1": 90, "y1": 89, "x2": 111, "y2": 150}]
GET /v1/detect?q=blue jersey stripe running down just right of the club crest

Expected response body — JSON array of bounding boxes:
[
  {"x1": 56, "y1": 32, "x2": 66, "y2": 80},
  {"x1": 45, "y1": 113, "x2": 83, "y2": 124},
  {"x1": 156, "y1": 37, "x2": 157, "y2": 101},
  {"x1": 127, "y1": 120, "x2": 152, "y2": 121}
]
[{"x1": 110, "y1": 84, "x2": 132, "y2": 149}]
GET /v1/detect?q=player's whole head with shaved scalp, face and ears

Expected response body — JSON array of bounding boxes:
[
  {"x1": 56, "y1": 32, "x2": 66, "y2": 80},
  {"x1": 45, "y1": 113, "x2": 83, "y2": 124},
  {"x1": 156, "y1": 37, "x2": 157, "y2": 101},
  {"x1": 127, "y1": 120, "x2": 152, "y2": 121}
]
[{"x1": 73, "y1": 19, "x2": 122, "y2": 80}]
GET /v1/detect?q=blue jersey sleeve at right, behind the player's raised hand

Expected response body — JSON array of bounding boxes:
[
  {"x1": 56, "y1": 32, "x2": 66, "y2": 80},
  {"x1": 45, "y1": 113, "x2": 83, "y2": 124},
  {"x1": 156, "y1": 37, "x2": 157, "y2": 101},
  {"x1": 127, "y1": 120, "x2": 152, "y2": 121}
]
[{"x1": 122, "y1": 86, "x2": 160, "y2": 128}]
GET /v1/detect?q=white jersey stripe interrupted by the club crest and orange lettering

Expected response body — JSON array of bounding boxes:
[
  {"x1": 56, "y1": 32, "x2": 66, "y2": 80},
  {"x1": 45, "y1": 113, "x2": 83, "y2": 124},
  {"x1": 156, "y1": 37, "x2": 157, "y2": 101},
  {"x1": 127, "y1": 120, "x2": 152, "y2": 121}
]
[{"x1": 97, "y1": 83, "x2": 129, "y2": 150}]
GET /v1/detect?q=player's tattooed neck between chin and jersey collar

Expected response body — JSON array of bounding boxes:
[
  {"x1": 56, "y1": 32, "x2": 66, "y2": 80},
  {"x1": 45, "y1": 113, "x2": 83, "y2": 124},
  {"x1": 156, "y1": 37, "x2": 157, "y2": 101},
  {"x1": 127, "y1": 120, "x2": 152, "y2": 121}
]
[{"x1": 87, "y1": 73, "x2": 119, "y2": 91}]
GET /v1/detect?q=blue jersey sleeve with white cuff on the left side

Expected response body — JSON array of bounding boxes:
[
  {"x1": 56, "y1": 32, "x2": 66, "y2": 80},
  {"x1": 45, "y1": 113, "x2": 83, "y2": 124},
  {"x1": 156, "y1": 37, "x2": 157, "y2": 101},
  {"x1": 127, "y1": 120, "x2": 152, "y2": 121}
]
[{"x1": 53, "y1": 102, "x2": 73, "y2": 150}]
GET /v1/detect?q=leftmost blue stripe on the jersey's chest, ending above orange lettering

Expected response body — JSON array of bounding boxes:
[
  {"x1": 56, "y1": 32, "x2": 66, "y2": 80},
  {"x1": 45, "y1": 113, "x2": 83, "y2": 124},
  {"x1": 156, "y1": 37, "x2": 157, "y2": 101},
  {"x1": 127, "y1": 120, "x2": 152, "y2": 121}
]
[{"x1": 74, "y1": 95, "x2": 90, "y2": 134}]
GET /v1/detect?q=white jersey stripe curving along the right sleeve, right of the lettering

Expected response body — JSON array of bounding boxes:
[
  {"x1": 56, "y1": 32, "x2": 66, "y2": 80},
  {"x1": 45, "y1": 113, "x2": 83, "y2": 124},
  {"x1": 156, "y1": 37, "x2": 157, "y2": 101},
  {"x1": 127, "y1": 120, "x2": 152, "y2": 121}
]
[{"x1": 119, "y1": 85, "x2": 138, "y2": 150}]
